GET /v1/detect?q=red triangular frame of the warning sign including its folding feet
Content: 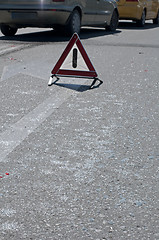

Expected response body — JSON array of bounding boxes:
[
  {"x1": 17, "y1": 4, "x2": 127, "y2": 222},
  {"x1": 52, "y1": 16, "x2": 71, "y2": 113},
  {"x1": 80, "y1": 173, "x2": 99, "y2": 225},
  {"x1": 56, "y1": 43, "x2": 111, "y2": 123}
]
[{"x1": 48, "y1": 33, "x2": 103, "y2": 88}]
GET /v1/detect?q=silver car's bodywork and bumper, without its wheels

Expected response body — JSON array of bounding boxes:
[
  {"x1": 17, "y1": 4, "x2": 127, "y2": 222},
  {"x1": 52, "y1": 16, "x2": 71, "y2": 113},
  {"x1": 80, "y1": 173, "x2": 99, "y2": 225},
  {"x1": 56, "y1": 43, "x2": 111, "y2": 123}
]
[{"x1": 0, "y1": 0, "x2": 117, "y2": 28}]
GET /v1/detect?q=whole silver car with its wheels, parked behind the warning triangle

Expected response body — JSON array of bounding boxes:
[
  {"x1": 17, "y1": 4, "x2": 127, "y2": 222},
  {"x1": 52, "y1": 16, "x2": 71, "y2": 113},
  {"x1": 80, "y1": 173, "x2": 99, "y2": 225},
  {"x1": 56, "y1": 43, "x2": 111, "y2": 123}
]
[{"x1": 0, "y1": 0, "x2": 119, "y2": 36}]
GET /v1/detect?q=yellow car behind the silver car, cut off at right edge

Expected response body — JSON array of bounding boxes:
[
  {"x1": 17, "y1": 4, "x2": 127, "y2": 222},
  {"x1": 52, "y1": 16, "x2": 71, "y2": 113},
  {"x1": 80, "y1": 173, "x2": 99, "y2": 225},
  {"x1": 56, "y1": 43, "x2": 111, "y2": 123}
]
[{"x1": 117, "y1": 0, "x2": 159, "y2": 27}]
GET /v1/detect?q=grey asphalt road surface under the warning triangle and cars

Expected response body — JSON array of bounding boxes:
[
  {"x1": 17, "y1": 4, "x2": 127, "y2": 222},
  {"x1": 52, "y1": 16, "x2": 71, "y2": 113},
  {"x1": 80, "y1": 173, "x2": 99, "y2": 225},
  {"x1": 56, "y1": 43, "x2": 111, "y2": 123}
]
[{"x1": 0, "y1": 22, "x2": 159, "y2": 240}]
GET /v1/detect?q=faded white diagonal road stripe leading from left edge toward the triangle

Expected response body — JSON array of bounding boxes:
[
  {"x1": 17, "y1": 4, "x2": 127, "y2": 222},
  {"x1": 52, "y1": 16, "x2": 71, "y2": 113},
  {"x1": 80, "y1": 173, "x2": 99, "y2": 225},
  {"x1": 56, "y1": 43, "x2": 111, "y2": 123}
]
[{"x1": 0, "y1": 83, "x2": 81, "y2": 162}]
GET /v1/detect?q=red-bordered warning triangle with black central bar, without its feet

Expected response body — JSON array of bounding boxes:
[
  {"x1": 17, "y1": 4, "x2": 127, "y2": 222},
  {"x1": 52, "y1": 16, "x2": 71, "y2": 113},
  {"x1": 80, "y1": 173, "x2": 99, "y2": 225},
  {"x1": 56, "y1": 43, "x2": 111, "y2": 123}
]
[{"x1": 51, "y1": 33, "x2": 97, "y2": 78}]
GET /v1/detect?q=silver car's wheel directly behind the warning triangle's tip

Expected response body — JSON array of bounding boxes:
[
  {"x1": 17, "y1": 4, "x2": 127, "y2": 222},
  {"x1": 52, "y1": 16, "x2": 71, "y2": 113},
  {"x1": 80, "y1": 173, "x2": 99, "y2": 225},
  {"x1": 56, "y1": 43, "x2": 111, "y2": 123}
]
[{"x1": 66, "y1": 10, "x2": 81, "y2": 35}]
